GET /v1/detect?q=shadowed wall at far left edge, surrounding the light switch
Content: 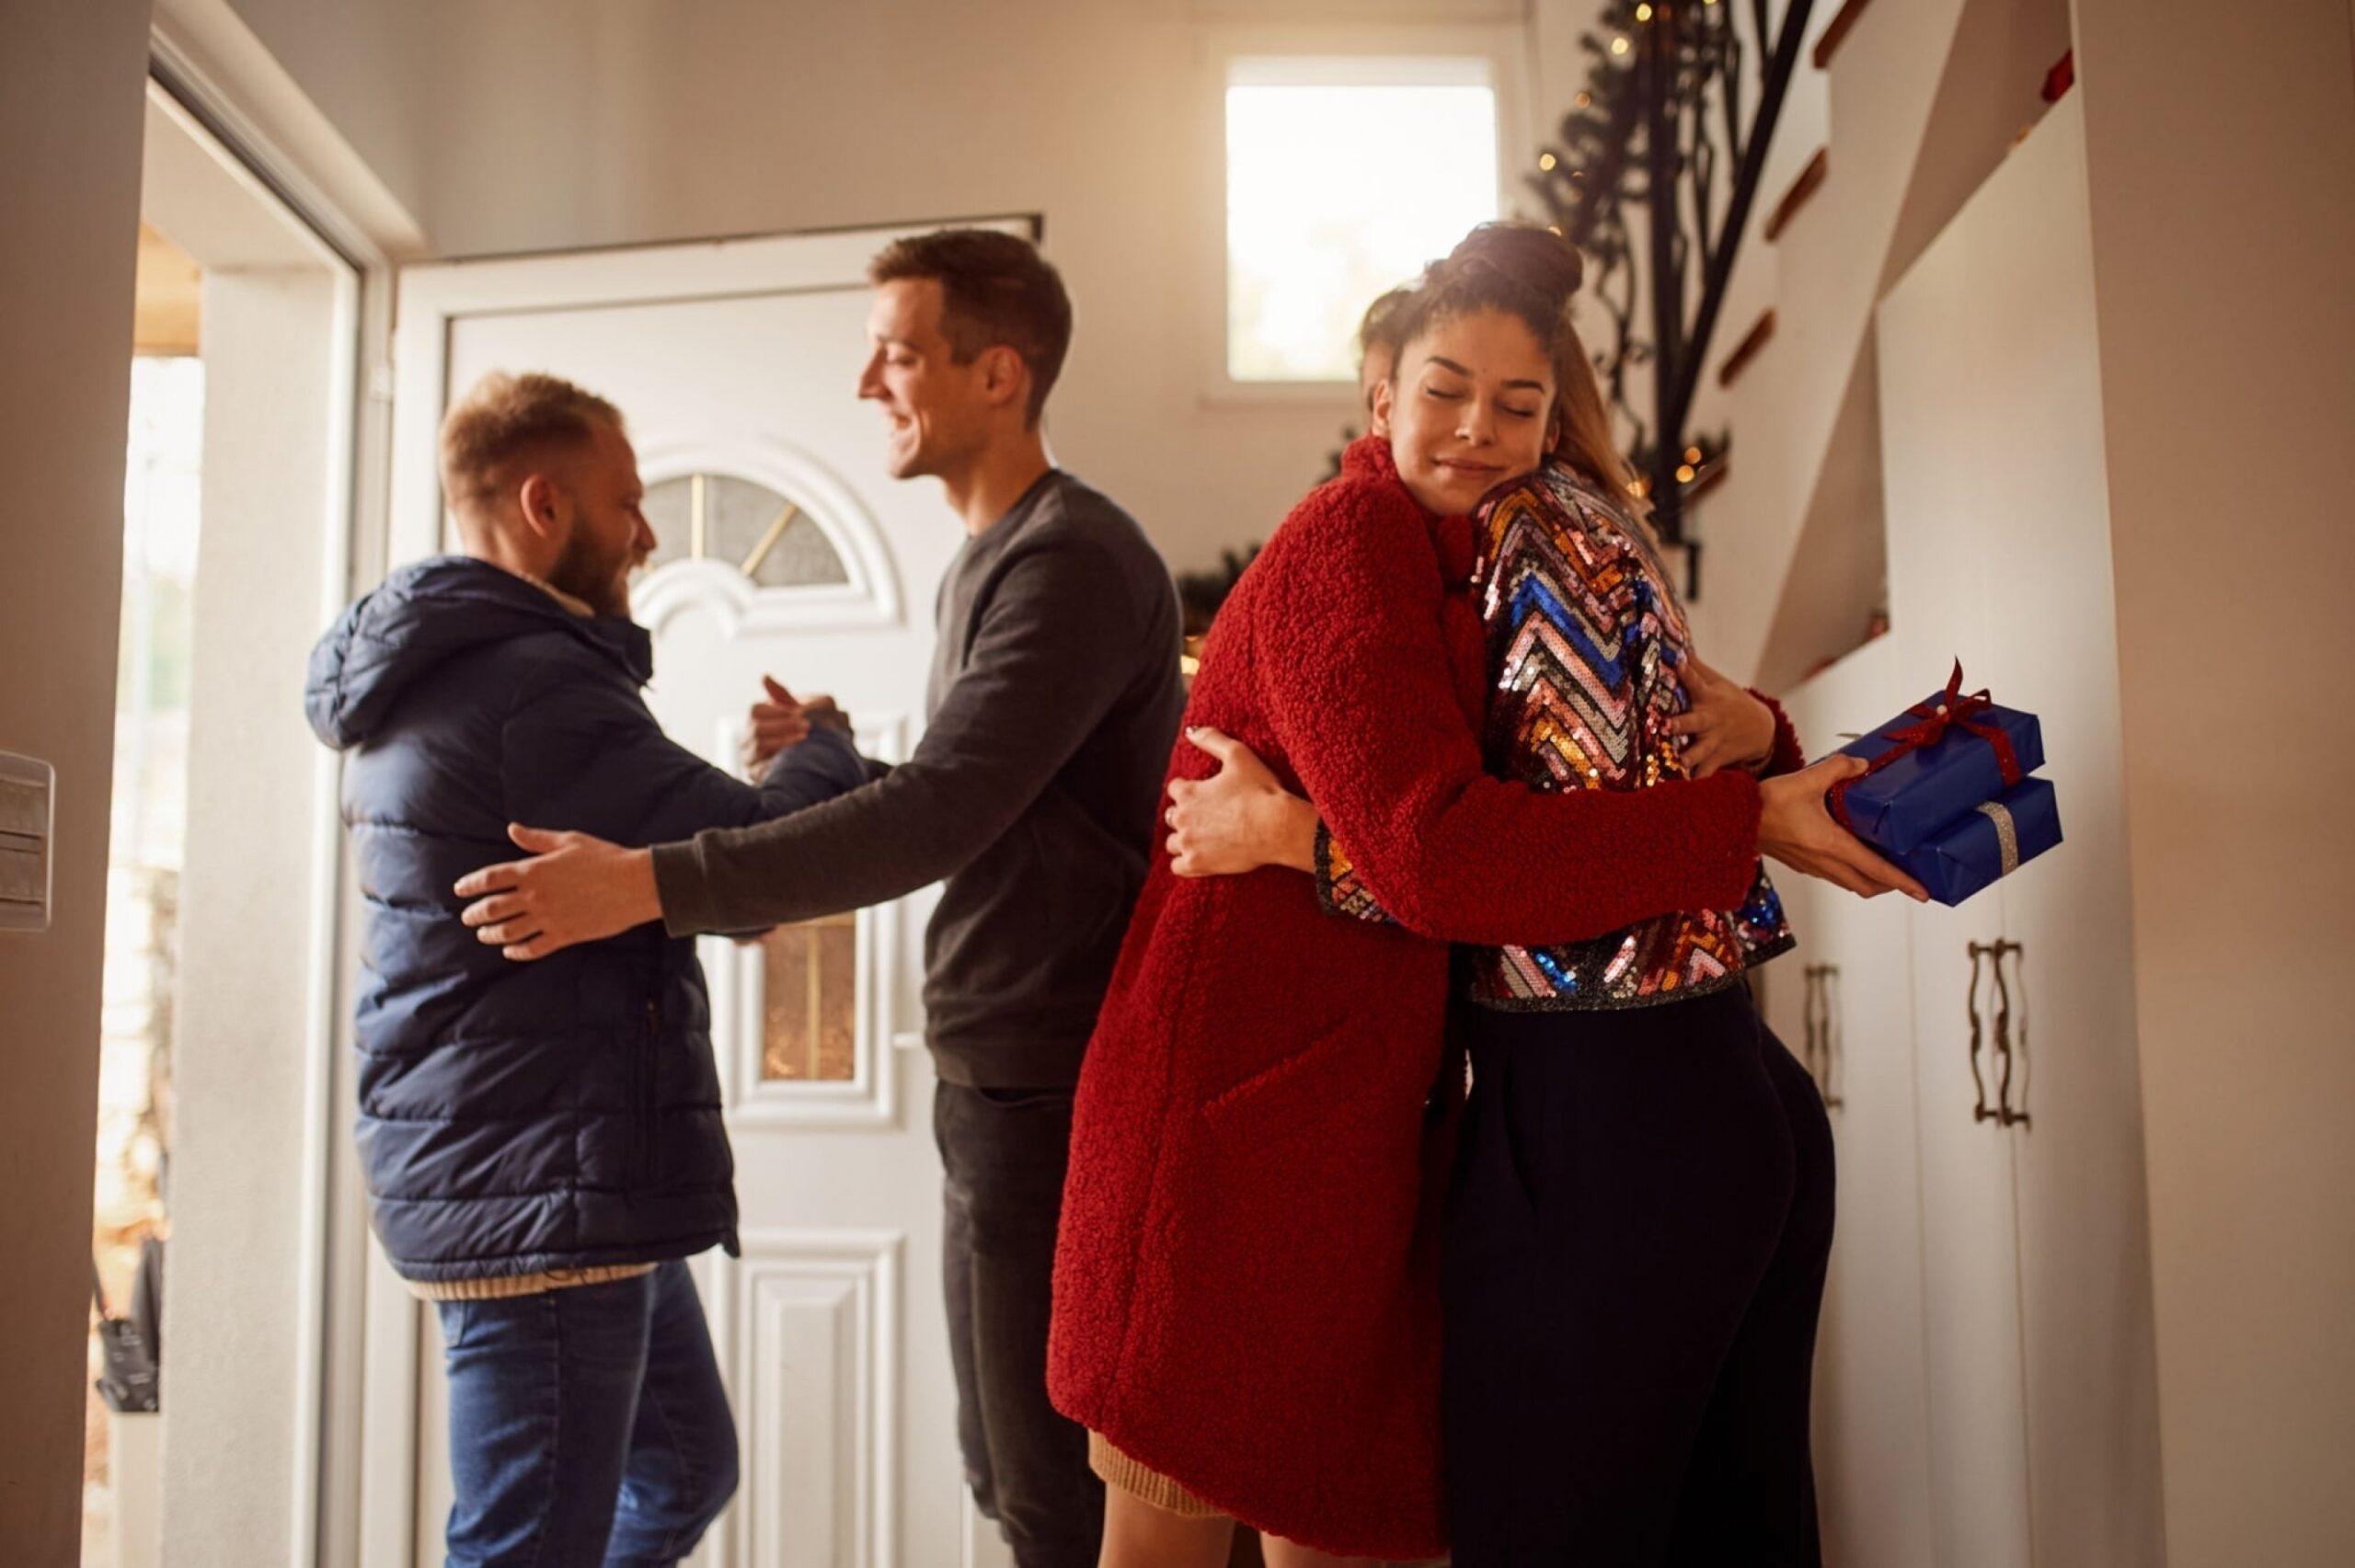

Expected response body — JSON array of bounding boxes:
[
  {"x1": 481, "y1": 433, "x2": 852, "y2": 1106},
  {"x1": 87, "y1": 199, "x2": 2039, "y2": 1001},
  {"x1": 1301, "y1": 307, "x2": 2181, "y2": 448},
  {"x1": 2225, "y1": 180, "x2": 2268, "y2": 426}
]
[{"x1": 0, "y1": 0, "x2": 148, "y2": 1568}]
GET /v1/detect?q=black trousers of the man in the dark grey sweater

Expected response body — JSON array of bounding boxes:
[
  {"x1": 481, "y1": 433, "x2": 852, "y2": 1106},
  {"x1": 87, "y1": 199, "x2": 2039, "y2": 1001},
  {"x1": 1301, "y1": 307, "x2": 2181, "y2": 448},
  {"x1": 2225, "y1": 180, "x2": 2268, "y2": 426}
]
[{"x1": 933, "y1": 1081, "x2": 1105, "y2": 1568}]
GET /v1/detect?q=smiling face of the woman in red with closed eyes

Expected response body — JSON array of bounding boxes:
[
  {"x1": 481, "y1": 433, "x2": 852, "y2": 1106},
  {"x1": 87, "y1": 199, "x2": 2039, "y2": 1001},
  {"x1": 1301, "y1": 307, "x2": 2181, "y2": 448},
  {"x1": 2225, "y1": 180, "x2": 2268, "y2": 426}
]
[{"x1": 1373, "y1": 311, "x2": 1555, "y2": 516}]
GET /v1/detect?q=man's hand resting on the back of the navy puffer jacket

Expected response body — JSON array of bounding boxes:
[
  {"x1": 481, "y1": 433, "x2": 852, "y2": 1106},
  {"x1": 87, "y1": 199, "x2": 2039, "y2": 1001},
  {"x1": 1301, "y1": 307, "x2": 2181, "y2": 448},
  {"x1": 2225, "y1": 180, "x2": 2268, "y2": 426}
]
[{"x1": 454, "y1": 824, "x2": 661, "y2": 963}]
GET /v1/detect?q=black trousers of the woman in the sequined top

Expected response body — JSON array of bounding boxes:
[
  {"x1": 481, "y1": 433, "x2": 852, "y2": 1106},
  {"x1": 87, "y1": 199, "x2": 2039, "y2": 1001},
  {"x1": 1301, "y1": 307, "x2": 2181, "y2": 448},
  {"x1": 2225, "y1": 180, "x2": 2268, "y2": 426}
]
[{"x1": 1443, "y1": 987, "x2": 1832, "y2": 1568}]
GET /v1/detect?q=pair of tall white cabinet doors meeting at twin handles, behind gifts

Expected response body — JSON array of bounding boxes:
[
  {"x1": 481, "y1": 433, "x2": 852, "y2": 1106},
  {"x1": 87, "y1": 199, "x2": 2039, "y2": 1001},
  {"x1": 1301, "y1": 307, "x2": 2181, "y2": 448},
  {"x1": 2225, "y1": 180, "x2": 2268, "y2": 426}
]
[{"x1": 1879, "y1": 99, "x2": 2165, "y2": 1568}]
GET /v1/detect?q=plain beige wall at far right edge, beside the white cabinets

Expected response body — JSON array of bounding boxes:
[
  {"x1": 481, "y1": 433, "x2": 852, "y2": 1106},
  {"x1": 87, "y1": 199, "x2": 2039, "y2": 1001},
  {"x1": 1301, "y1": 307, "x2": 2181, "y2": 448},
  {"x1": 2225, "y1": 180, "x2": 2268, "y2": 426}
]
[{"x1": 2077, "y1": 0, "x2": 2355, "y2": 1568}]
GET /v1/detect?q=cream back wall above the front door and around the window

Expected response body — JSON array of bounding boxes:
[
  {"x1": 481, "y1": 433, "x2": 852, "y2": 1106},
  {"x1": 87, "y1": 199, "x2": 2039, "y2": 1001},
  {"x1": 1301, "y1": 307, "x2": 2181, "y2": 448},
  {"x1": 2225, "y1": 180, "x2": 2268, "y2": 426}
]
[{"x1": 221, "y1": 0, "x2": 1554, "y2": 570}]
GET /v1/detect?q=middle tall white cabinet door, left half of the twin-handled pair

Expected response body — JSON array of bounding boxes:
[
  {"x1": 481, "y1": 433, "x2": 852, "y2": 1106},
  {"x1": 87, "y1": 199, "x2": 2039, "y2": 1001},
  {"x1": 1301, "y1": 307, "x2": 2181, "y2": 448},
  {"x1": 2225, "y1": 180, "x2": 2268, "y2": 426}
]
[{"x1": 1877, "y1": 161, "x2": 2032, "y2": 1568}]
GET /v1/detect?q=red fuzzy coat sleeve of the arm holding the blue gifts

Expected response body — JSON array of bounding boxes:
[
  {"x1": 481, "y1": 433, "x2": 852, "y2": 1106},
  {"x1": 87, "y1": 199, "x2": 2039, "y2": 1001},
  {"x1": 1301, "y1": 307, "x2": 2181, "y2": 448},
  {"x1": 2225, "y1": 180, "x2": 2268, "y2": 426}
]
[{"x1": 1262, "y1": 483, "x2": 1759, "y2": 944}]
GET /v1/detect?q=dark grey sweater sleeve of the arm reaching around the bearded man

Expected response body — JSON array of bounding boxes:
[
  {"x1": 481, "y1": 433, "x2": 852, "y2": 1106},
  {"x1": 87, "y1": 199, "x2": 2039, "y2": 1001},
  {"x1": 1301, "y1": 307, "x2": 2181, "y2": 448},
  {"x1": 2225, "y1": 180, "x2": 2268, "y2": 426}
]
[{"x1": 655, "y1": 539, "x2": 1147, "y2": 934}]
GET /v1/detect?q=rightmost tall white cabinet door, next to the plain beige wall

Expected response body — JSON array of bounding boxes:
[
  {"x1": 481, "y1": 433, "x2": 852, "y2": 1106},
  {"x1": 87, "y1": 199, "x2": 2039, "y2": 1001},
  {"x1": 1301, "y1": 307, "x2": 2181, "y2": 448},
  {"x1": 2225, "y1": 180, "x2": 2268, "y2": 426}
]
[{"x1": 1952, "y1": 94, "x2": 2190, "y2": 1568}]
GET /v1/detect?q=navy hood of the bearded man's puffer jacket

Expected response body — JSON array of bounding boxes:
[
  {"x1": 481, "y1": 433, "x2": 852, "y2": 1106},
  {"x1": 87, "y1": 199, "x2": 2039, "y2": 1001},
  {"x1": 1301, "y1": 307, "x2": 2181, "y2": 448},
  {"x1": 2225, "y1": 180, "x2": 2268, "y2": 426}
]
[{"x1": 304, "y1": 555, "x2": 655, "y2": 751}]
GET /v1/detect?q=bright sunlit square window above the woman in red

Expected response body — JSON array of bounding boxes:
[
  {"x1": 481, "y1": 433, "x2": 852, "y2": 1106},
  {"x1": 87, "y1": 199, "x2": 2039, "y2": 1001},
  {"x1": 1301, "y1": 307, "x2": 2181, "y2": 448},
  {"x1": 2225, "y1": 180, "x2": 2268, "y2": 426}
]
[{"x1": 1227, "y1": 59, "x2": 1498, "y2": 382}]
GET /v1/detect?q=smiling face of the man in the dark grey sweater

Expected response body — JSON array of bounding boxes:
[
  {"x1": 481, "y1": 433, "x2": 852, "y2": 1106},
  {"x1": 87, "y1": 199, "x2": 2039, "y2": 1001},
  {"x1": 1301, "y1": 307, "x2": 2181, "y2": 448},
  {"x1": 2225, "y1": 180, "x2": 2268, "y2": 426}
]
[{"x1": 859, "y1": 278, "x2": 1019, "y2": 478}]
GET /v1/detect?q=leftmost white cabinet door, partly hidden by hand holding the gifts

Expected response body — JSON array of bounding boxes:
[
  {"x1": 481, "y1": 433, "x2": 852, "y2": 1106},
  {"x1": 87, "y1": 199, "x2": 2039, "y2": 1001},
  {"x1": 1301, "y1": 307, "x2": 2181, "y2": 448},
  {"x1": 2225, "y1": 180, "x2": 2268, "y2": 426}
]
[{"x1": 1763, "y1": 638, "x2": 1931, "y2": 1568}]
